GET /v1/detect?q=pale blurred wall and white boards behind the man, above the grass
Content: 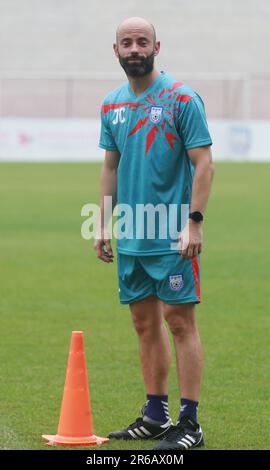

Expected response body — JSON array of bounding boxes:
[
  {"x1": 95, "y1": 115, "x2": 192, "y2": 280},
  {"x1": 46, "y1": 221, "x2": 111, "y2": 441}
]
[{"x1": 0, "y1": 0, "x2": 270, "y2": 161}]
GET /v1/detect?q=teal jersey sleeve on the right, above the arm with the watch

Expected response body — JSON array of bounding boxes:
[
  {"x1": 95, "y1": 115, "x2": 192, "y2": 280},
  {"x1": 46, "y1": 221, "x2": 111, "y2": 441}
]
[{"x1": 178, "y1": 94, "x2": 212, "y2": 150}]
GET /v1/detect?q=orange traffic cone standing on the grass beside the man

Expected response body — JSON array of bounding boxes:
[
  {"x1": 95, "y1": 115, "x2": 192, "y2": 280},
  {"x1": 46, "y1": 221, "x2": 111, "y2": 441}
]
[{"x1": 42, "y1": 331, "x2": 109, "y2": 447}]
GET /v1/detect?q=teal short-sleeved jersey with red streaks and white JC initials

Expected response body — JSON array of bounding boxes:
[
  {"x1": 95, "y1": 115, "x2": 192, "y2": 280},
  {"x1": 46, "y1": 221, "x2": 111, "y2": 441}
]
[{"x1": 99, "y1": 72, "x2": 212, "y2": 256}]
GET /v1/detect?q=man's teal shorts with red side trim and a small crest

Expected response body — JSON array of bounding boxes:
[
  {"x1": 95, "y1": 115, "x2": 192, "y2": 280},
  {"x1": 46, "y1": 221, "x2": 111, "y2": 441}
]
[{"x1": 117, "y1": 253, "x2": 200, "y2": 304}]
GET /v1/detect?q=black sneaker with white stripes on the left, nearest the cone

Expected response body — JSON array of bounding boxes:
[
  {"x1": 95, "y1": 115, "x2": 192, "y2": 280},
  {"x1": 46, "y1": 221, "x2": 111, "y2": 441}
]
[{"x1": 108, "y1": 416, "x2": 172, "y2": 440}]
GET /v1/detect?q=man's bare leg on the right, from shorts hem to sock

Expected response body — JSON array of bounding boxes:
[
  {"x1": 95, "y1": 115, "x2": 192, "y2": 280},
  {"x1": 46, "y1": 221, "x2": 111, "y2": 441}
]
[{"x1": 163, "y1": 304, "x2": 203, "y2": 401}]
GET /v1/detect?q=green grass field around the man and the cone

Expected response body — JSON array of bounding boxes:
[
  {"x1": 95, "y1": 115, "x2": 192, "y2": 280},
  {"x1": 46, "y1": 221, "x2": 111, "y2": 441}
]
[{"x1": 0, "y1": 163, "x2": 270, "y2": 450}]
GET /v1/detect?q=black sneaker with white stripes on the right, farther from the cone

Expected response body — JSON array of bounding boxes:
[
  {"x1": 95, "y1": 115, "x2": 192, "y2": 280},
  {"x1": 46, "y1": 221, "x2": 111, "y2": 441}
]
[{"x1": 154, "y1": 416, "x2": 204, "y2": 450}]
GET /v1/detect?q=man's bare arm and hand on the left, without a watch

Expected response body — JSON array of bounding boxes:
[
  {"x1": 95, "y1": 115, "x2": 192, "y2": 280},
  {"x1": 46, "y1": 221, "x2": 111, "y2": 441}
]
[{"x1": 94, "y1": 150, "x2": 120, "y2": 263}]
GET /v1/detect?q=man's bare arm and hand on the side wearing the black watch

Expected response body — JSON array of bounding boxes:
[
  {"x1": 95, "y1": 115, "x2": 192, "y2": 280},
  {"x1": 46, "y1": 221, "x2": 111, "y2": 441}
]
[{"x1": 180, "y1": 146, "x2": 214, "y2": 259}]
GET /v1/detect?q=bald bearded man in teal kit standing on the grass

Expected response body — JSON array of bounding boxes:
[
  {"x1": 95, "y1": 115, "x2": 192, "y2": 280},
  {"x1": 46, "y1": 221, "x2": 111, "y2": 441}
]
[{"x1": 95, "y1": 17, "x2": 213, "y2": 450}]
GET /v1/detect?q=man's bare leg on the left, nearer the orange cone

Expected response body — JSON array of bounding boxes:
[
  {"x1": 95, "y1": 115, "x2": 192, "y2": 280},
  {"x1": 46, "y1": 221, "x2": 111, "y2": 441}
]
[{"x1": 130, "y1": 296, "x2": 171, "y2": 395}]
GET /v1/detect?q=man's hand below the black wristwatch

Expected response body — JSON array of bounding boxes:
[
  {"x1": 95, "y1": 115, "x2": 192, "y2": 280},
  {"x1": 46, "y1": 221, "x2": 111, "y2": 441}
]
[{"x1": 179, "y1": 219, "x2": 203, "y2": 259}]
